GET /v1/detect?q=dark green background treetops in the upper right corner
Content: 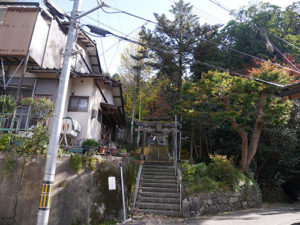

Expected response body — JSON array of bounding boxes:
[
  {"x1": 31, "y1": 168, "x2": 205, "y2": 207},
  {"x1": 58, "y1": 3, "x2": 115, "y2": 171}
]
[{"x1": 193, "y1": 1, "x2": 300, "y2": 74}]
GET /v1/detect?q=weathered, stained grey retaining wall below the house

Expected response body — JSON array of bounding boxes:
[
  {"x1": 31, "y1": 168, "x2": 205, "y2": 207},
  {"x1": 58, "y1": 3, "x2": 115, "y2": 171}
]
[{"x1": 0, "y1": 154, "x2": 135, "y2": 225}]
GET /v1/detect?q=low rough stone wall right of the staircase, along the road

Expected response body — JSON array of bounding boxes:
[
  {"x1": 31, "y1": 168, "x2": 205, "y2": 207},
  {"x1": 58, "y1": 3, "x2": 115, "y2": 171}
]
[{"x1": 183, "y1": 188, "x2": 262, "y2": 217}]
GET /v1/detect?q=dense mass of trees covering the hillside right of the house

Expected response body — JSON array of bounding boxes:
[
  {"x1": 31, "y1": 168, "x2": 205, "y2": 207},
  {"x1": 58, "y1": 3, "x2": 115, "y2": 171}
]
[{"x1": 121, "y1": 0, "x2": 300, "y2": 200}]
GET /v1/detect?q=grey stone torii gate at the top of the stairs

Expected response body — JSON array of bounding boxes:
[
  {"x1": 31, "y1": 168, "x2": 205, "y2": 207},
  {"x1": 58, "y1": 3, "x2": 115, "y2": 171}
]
[{"x1": 134, "y1": 116, "x2": 181, "y2": 165}]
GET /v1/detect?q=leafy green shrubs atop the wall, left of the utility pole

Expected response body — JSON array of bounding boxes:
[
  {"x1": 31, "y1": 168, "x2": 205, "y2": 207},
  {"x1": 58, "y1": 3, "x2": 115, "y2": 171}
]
[{"x1": 0, "y1": 96, "x2": 54, "y2": 155}]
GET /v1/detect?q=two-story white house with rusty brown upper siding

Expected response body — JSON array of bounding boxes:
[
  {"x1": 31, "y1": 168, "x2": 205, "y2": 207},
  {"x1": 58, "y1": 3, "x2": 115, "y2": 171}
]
[{"x1": 0, "y1": 2, "x2": 125, "y2": 144}]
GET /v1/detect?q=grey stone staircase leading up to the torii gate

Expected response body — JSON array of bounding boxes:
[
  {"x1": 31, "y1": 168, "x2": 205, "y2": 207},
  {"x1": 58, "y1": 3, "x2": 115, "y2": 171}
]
[{"x1": 137, "y1": 161, "x2": 181, "y2": 216}]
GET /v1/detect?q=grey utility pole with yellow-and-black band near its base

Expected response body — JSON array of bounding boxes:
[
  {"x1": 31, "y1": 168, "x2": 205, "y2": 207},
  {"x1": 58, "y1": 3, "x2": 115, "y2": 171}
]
[{"x1": 37, "y1": 0, "x2": 104, "y2": 225}]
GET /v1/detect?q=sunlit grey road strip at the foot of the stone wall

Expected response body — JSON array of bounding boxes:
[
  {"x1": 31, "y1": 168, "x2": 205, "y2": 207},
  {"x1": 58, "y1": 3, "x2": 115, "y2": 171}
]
[{"x1": 125, "y1": 203, "x2": 300, "y2": 225}]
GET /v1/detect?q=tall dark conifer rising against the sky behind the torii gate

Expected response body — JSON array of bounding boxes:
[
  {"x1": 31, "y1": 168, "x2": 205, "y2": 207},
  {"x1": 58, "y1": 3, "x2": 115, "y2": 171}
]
[{"x1": 145, "y1": 0, "x2": 218, "y2": 109}]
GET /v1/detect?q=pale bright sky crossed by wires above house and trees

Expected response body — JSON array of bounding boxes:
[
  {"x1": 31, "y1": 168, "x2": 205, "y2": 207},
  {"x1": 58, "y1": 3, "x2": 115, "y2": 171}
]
[{"x1": 24, "y1": 0, "x2": 295, "y2": 75}]
